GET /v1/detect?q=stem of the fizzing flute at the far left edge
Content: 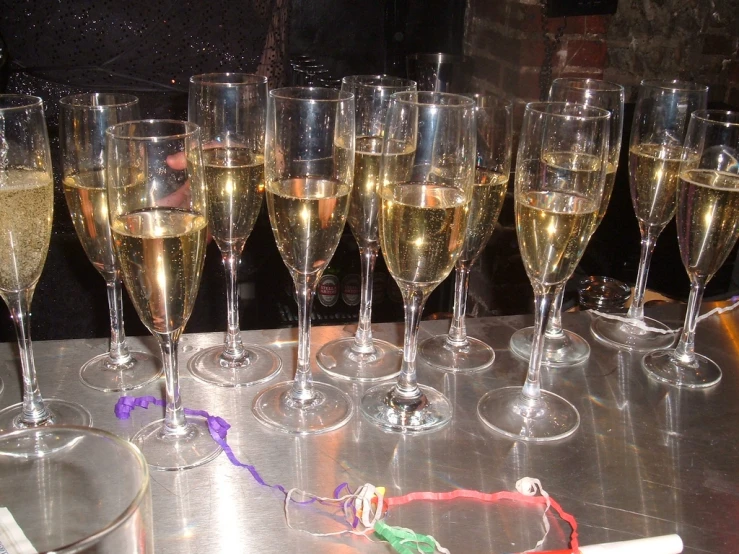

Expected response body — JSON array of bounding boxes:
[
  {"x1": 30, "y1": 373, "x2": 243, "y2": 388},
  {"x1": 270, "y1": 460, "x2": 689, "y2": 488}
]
[{"x1": 5, "y1": 289, "x2": 51, "y2": 426}]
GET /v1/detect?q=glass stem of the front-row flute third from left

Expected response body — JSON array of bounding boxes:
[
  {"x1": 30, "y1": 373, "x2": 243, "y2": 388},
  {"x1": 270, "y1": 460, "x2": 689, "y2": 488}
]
[{"x1": 291, "y1": 272, "x2": 321, "y2": 402}]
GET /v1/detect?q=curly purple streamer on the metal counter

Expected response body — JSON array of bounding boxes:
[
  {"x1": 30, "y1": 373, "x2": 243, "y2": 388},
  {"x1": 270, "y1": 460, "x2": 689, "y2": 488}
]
[{"x1": 113, "y1": 396, "x2": 359, "y2": 512}]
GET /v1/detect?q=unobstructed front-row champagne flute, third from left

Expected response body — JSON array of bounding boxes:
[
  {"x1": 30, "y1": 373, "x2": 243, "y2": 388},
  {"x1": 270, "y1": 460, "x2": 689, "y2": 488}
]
[{"x1": 252, "y1": 87, "x2": 354, "y2": 435}]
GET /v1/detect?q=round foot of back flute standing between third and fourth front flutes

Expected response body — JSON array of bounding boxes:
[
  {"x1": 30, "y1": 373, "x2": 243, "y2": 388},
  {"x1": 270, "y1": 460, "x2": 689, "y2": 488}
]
[{"x1": 316, "y1": 337, "x2": 403, "y2": 383}]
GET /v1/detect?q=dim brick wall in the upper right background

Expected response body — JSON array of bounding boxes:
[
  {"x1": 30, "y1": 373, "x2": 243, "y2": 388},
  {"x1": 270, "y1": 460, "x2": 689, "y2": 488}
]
[{"x1": 464, "y1": 0, "x2": 739, "y2": 110}]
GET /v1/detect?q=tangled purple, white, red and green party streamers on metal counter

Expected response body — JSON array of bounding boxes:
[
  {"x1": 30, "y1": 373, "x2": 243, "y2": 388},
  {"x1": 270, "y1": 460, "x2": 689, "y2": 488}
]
[{"x1": 114, "y1": 396, "x2": 579, "y2": 554}]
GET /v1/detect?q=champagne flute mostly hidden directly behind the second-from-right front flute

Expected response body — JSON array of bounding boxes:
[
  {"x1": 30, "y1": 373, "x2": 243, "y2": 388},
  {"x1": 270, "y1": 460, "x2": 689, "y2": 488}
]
[{"x1": 510, "y1": 77, "x2": 624, "y2": 367}]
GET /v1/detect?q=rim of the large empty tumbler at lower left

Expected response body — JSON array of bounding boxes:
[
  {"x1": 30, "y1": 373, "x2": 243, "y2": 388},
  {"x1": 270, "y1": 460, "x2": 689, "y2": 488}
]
[{"x1": 0, "y1": 425, "x2": 153, "y2": 553}]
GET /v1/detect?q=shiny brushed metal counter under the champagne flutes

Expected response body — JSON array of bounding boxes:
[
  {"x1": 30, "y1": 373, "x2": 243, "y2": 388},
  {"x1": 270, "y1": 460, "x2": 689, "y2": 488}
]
[{"x1": 0, "y1": 305, "x2": 739, "y2": 554}]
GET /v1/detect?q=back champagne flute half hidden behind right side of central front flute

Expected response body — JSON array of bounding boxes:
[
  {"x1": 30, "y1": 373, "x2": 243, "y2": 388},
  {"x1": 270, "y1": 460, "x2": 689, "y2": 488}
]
[{"x1": 418, "y1": 95, "x2": 512, "y2": 372}]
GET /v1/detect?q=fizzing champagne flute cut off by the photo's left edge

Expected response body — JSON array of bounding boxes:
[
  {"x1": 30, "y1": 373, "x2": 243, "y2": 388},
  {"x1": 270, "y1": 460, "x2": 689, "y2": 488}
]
[{"x1": 0, "y1": 94, "x2": 92, "y2": 436}]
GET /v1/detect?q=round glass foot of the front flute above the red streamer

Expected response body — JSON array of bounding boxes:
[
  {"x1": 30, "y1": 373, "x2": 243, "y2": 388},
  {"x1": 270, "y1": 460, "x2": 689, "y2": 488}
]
[{"x1": 477, "y1": 387, "x2": 580, "y2": 442}]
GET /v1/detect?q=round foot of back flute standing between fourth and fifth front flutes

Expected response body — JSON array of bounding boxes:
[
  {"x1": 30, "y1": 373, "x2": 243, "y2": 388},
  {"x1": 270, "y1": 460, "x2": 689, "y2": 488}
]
[{"x1": 416, "y1": 335, "x2": 495, "y2": 373}]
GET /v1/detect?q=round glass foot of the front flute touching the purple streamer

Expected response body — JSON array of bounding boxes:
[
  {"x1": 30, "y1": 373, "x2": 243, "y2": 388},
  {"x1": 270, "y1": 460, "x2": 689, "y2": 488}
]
[{"x1": 131, "y1": 416, "x2": 221, "y2": 471}]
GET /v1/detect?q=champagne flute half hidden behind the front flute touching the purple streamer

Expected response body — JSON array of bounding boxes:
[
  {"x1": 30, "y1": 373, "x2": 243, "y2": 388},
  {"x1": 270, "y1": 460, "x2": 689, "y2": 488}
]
[{"x1": 59, "y1": 93, "x2": 162, "y2": 391}]
